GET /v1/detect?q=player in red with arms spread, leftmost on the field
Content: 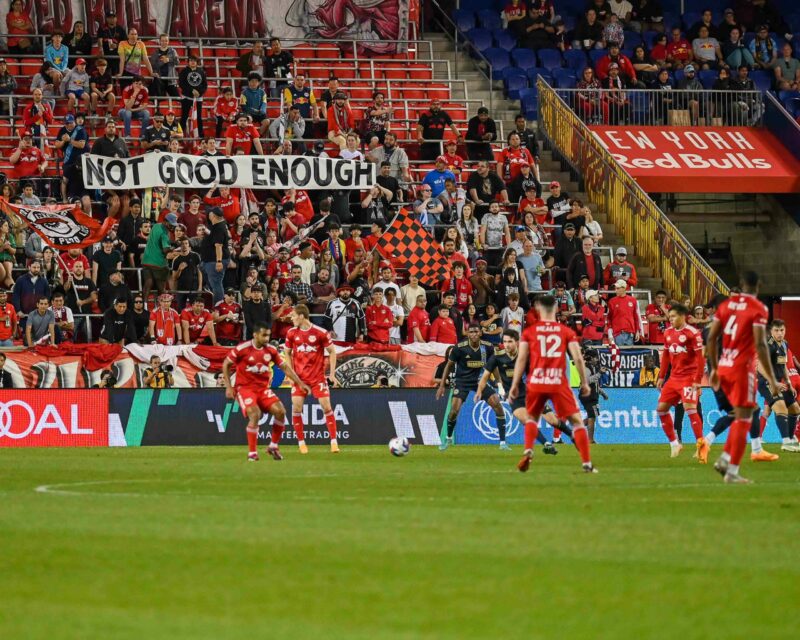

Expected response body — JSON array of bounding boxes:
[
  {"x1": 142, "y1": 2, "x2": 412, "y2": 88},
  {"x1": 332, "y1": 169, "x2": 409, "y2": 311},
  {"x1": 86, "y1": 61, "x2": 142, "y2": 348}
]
[{"x1": 222, "y1": 321, "x2": 309, "y2": 462}]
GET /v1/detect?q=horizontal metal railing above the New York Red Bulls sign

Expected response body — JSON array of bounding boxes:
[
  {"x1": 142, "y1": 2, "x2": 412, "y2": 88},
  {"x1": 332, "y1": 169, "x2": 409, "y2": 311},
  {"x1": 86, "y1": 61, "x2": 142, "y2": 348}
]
[{"x1": 553, "y1": 88, "x2": 765, "y2": 127}]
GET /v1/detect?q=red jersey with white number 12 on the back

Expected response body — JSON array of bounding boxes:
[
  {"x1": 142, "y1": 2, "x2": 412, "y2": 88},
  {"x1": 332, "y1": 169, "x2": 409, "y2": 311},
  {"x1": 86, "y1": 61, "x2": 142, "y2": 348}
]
[{"x1": 520, "y1": 320, "x2": 578, "y2": 391}]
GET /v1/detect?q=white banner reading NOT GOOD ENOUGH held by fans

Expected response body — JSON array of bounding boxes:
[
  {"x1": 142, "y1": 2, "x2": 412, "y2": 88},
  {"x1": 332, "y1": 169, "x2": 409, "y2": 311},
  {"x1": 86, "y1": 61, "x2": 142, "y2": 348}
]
[{"x1": 82, "y1": 152, "x2": 377, "y2": 190}]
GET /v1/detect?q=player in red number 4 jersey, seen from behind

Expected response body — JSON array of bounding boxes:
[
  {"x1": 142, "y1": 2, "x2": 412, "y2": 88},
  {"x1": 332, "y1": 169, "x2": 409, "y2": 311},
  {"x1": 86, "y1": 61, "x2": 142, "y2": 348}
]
[{"x1": 707, "y1": 271, "x2": 779, "y2": 484}]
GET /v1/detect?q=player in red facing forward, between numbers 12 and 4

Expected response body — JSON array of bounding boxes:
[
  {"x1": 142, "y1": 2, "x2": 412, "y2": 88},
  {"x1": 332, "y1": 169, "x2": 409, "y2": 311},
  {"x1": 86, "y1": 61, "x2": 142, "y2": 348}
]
[{"x1": 656, "y1": 304, "x2": 708, "y2": 464}]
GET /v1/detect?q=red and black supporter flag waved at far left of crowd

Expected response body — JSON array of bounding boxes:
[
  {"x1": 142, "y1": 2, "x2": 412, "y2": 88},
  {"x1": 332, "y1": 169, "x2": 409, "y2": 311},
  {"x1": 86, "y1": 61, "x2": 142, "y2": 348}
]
[{"x1": 0, "y1": 201, "x2": 116, "y2": 251}]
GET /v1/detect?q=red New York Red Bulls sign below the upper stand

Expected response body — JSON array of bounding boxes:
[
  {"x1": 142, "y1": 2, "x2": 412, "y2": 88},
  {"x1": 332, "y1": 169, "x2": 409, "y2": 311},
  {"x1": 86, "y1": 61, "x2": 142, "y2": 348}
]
[{"x1": 590, "y1": 126, "x2": 800, "y2": 193}]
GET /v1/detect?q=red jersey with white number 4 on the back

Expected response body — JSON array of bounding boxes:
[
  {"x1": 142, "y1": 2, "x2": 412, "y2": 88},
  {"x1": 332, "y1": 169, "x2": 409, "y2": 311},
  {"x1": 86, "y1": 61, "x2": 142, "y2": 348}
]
[{"x1": 714, "y1": 293, "x2": 768, "y2": 372}]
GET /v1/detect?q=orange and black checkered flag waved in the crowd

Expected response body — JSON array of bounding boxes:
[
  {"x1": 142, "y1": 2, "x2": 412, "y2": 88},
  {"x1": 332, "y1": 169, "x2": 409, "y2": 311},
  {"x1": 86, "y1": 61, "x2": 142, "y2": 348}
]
[{"x1": 375, "y1": 209, "x2": 450, "y2": 287}]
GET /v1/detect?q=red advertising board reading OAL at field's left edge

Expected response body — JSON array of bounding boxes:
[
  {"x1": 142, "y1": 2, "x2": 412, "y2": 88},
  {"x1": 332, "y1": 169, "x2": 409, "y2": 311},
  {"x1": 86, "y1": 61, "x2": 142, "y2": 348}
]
[{"x1": 0, "y1": 389, "x2": 108, "y2": 447}]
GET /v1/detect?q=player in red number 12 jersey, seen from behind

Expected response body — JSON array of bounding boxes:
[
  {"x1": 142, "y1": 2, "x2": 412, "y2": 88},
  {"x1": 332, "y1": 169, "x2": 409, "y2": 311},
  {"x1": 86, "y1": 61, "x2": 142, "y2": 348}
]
[{"x1": 508, "y1": 294, "x2": 597, "y2": 473}]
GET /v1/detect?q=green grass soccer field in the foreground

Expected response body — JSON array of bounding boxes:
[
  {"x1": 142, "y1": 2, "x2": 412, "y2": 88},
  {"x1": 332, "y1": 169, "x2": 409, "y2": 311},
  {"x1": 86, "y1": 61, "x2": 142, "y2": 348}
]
[{"x1": 0, "y1": 445, "x2": 800, "y2": 640}]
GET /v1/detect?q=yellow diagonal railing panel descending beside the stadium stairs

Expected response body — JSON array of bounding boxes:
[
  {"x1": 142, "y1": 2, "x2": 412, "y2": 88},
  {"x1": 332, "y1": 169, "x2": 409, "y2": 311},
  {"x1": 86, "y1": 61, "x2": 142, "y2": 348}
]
[{"x1": 537, "y1": 78, "x2": 729, "y2": 302}]
